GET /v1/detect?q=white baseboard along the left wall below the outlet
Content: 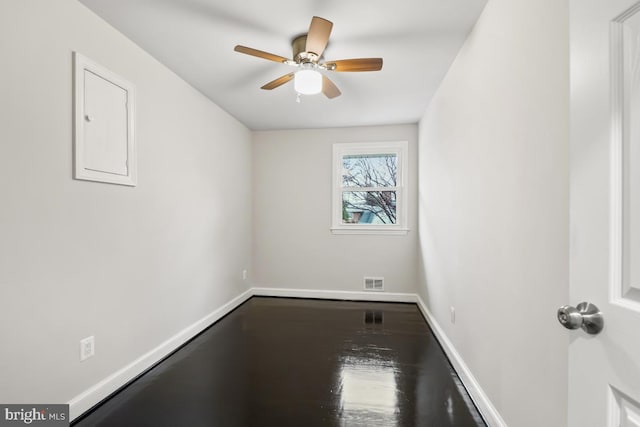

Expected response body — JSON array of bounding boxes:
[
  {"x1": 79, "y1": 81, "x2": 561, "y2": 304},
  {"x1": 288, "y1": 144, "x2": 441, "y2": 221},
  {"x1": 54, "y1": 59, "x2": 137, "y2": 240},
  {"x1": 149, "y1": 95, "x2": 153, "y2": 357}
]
[{"x1": 67, "y1": 289, "x2": 252, "y2": 421}]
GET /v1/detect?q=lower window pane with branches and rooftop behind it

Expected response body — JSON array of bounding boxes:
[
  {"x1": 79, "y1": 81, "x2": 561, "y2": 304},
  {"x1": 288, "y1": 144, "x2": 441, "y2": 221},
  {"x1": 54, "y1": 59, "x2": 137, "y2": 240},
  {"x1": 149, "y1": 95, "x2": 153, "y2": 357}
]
[{"x1": 342, "y1": 191, "x2": 396, "y2": 224}]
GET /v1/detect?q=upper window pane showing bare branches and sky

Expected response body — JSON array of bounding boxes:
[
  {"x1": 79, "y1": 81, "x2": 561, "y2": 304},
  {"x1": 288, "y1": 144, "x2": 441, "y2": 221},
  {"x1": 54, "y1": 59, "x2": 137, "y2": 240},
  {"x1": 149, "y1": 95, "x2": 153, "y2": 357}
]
[{"x1": 342, "y1": 154, "x2": 398, "y2": 187}]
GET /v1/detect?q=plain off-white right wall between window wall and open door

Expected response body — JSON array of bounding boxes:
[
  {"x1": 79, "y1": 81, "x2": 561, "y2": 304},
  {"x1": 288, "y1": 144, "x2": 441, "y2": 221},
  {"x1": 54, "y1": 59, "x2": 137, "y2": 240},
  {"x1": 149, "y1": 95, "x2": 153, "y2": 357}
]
[{"x1": 419, "y1": 0, "x2": 569, "y2": 427}]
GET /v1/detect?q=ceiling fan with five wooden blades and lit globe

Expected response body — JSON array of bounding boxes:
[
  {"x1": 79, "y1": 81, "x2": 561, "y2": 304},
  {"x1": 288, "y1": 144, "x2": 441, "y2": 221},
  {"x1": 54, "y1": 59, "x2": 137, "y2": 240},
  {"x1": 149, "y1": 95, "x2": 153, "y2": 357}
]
[{"x1": 234, "y1": 16, "x2": 382, "y2": 99}]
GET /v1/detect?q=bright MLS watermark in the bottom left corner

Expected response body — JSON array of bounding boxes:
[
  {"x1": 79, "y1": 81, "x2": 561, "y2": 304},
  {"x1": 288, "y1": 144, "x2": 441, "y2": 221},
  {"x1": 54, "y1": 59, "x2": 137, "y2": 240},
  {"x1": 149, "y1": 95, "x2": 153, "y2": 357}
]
[{"x1": 0, "y1": 404, "x2": 69, "y2": 427}]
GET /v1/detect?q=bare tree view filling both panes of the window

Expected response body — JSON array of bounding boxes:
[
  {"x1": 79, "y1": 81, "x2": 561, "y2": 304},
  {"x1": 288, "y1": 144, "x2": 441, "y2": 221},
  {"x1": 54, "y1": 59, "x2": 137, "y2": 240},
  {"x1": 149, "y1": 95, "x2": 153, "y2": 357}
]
[{"x1": 342, "y1": 154, "x2": 398, "y2": 224}]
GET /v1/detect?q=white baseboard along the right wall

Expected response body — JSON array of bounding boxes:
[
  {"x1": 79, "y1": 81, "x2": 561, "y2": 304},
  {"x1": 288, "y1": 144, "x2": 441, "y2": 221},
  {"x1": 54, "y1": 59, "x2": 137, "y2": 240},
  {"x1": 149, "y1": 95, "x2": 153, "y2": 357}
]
[{"x1": 415, "y1": 295, "x2": 507, "y2": 427}]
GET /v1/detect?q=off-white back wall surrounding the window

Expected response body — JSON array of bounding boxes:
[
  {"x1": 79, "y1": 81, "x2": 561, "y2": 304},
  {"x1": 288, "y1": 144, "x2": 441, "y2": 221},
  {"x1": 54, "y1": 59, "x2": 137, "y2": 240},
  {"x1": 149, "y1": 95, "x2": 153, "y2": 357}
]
[{"x1": 253, "y1": 125, "x2": 417, "y2": 293}]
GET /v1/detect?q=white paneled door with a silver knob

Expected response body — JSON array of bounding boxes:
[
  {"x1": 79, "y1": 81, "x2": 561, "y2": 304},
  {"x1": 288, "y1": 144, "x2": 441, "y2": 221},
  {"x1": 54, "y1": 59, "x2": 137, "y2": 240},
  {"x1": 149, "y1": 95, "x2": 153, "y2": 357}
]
[{"x1": 568, "y1": 0, "x2": 640, "y2": 427}]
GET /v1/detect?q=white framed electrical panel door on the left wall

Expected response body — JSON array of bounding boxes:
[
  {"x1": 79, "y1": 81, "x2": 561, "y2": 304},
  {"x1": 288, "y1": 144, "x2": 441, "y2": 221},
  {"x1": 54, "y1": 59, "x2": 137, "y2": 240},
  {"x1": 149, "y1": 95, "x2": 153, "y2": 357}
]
[{"x1": 75, "y1": 53, "x2": 136, "y2": 185}]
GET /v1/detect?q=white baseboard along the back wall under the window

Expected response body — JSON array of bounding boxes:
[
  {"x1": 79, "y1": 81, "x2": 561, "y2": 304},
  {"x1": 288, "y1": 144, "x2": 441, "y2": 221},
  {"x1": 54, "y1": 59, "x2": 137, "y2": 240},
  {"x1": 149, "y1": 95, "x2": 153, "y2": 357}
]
[{"x1": 251, "y1": 287, "x2": 416, "y2": 303}]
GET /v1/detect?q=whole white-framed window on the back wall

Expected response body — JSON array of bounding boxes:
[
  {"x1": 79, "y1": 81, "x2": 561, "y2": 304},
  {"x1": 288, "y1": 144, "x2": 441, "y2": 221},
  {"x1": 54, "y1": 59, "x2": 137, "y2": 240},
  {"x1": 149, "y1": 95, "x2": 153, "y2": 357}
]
[{"x1": 331, "y1": 141, "x2": 408, "y2": 234}]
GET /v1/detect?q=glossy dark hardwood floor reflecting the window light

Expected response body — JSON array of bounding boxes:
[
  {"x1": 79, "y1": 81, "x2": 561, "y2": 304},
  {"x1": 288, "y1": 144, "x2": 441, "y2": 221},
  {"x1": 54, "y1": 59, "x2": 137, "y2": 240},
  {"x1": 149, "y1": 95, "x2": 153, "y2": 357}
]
[{"x1": 73, "y1": 297, "x2": 485, "y2": 427}]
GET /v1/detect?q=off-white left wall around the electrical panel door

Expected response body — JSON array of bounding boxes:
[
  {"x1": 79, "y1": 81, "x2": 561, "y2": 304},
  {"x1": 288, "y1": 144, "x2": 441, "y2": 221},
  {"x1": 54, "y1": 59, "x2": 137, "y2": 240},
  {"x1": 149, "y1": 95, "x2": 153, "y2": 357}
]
[{"x1": 0, "y1": 0, "x2": 251, "y2": 416}]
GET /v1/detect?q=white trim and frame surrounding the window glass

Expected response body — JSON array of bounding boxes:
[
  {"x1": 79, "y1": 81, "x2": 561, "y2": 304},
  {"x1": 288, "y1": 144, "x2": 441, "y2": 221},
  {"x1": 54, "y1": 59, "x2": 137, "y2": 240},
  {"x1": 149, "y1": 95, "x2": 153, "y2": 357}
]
[{"x1": 331, "y1": 141, "x2": 409, "y2": 235}]
